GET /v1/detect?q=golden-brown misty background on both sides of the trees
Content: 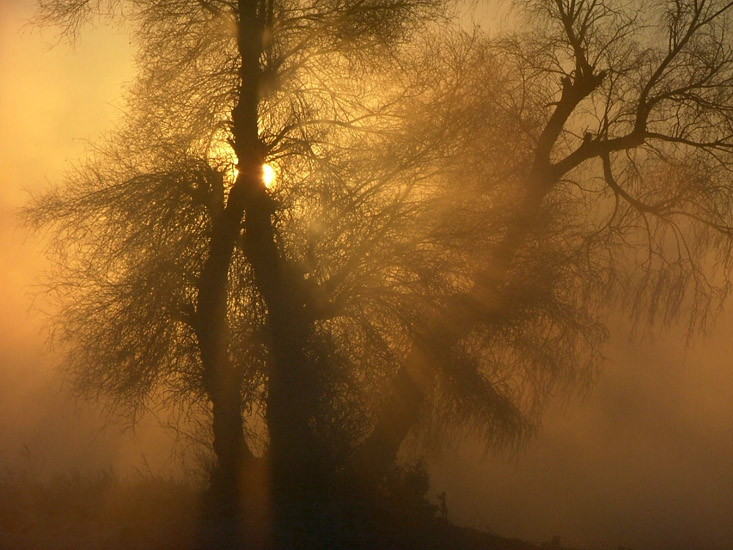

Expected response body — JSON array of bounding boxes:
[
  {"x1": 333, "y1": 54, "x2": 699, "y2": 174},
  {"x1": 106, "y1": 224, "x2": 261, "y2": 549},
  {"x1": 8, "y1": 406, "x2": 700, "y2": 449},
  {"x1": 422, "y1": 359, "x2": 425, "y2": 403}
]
[{"x1": 0, "y1": 0, "x2": 733, "y2": 550}]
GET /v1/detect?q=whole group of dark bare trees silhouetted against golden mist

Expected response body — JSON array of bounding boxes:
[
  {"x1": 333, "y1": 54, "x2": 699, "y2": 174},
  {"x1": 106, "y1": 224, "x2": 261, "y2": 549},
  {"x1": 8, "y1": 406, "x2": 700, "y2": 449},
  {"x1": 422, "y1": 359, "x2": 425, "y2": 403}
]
[{"x1": 29, "y1": 0, "x2": 733, "y2": 544}]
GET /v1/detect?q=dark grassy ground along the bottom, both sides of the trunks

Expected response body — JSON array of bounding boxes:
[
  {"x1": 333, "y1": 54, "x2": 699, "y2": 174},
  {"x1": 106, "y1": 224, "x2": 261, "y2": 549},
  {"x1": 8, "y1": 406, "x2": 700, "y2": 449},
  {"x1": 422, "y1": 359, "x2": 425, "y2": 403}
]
[{"x1": 0, "y1": 470, "x2": 548, "y2": 550}]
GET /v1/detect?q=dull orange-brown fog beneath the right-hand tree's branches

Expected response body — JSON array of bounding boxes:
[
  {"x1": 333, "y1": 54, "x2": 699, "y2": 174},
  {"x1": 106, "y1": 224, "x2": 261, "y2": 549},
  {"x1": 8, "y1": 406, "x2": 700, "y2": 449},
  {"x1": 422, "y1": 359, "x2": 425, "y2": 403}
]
[{"x1": 434, "y1": 324, "x2": 733, "y2": 549}]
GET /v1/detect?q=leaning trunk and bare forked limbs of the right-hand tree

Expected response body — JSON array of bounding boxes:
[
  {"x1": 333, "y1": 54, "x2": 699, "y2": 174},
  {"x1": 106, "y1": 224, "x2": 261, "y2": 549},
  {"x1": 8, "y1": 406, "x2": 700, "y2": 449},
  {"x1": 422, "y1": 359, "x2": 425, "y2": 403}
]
[{"x1": 358, "y1": 0, "x2": 730, "y2": 478}]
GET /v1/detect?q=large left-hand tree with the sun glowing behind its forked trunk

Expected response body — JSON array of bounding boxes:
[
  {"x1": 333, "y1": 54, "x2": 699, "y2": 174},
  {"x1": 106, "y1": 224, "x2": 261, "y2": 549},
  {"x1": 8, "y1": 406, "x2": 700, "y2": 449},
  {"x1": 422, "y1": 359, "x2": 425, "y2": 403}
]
[{"x1": 30, "y1": 0, "x2": 464, "y2": 520}]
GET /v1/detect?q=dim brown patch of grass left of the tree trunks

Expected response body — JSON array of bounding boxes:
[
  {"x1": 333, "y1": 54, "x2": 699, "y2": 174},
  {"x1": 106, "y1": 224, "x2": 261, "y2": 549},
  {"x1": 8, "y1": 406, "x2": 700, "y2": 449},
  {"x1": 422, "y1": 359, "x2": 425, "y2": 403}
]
[{"x1": 0, "y1": 471, "x2": 200, "y2": 550}]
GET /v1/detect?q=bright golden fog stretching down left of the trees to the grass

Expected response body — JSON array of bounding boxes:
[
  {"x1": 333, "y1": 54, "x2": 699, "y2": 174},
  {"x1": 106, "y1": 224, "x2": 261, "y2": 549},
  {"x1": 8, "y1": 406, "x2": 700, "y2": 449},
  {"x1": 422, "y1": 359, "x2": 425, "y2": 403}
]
[{"x1": 0, "y1": 0, "x2": 167, "y2": 471}]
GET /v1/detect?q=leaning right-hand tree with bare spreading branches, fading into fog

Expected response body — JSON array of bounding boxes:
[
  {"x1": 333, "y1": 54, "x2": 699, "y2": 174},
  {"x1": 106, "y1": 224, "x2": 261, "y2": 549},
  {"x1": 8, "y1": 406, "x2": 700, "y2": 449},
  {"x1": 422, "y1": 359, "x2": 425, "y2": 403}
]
[{"x1": 362, "y1": 0, "x2": 733, "y2": 471}]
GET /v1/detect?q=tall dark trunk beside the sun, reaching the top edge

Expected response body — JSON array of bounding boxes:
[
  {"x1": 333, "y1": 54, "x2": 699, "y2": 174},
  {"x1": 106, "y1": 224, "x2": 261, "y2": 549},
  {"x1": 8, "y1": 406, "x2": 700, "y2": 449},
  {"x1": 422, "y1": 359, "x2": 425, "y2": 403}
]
[{"x1": 229, "y1": 0, "x2": 318, "y2": 500}]
